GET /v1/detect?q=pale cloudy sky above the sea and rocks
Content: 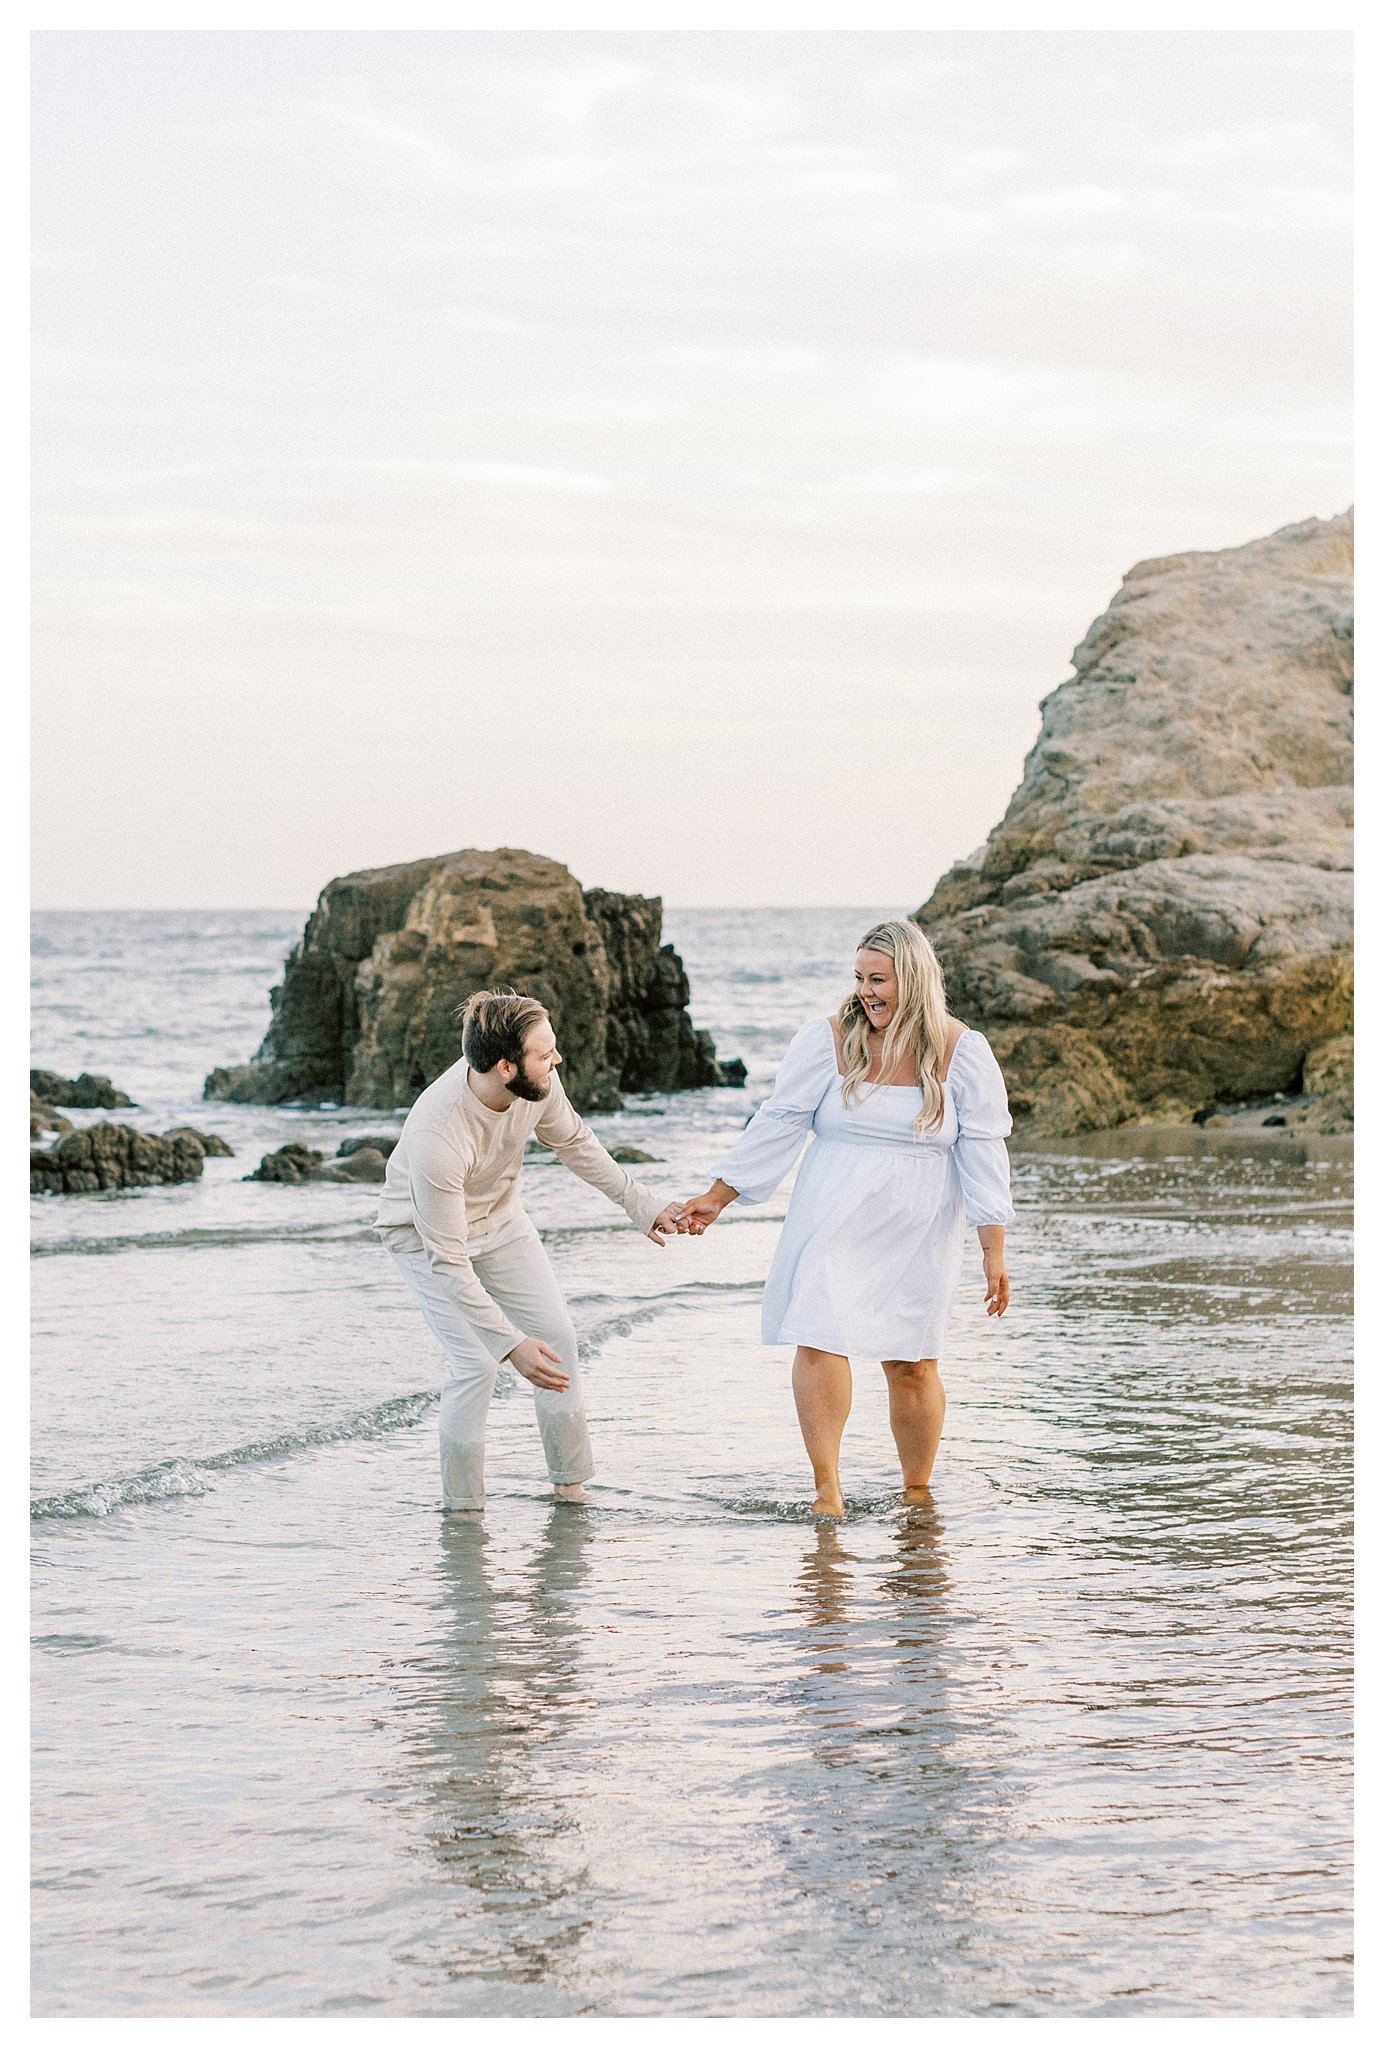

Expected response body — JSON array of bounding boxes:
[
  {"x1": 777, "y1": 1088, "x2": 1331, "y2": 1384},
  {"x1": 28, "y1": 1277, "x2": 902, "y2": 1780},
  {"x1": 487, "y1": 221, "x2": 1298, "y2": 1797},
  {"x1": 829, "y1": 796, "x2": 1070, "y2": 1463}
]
[{"x1": 33, "y1": 31, "x2": 1351, "y2": 907}]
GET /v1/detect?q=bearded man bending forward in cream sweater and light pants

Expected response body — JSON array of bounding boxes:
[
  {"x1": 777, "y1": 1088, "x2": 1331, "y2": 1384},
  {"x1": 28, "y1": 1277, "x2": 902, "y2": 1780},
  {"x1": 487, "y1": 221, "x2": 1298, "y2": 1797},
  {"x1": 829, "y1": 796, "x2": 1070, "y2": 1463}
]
[{"x1": 375, "y1": 989, "x2": 678, "y2": 1507}]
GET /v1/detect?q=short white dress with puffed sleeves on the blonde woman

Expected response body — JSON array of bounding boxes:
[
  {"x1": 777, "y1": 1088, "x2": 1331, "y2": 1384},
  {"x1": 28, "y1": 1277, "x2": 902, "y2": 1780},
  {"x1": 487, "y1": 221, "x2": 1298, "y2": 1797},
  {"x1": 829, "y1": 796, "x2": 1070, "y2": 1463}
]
[{"x1": 715, "y1": 1018, "x2": 1013, "y2": 1360}]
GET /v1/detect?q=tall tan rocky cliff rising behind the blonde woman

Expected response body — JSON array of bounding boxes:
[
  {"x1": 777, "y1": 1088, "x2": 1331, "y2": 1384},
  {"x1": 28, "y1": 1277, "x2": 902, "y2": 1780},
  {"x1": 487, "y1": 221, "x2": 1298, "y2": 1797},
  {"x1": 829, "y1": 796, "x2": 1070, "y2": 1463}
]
[{"x1": 915, "y1": 512, "x2": 1353, "y2": 1133}]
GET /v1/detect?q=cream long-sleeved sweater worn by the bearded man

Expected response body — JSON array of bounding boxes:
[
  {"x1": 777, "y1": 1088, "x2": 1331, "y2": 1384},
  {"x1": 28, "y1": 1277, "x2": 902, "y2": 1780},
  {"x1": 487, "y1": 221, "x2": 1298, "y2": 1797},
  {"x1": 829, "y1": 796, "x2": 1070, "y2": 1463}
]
[{"x1": 375, "y1": 1059, "x2": 663, "y2": 1358}]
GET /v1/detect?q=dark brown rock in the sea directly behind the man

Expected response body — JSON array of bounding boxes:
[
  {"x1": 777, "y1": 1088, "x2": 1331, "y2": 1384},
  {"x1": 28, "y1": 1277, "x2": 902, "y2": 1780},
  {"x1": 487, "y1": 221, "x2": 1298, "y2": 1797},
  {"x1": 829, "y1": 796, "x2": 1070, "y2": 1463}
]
[{"x1": 205, "y1": 848, "x2": 723, "y2": 1108}]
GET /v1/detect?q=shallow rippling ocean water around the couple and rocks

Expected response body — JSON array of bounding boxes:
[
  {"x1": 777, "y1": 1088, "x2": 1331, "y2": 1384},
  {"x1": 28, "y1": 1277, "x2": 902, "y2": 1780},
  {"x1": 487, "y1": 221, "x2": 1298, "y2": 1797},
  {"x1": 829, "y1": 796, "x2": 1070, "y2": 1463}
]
[{"x1": 33, "y1": 911, "x2": 1351, "y2": 2017}]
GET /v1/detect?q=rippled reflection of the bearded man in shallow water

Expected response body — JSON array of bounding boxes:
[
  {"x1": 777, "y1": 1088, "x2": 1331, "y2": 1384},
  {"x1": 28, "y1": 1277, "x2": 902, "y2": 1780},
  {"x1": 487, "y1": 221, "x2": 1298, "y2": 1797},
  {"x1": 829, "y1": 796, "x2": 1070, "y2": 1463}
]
[{"x1": 395, "y1": 1507, "x2": 594, "y2": 1985}]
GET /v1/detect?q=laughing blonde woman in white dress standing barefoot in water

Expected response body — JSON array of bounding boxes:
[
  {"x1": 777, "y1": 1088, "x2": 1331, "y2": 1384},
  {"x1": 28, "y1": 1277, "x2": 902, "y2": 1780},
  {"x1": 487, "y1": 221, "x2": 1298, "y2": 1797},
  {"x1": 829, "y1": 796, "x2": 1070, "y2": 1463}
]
[{"x1": 680, "y1": 920, "x2": 1013, "y2": 1516}]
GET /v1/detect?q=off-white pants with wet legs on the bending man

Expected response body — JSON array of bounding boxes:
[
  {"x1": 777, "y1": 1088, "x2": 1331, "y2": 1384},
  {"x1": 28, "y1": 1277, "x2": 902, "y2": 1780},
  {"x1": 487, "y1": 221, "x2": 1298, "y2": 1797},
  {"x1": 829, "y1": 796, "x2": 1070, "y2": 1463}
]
[{"x1": 393, "y1": 1214, "x2": 596, "y2": 1507}]
